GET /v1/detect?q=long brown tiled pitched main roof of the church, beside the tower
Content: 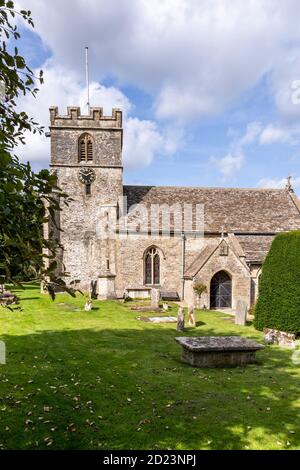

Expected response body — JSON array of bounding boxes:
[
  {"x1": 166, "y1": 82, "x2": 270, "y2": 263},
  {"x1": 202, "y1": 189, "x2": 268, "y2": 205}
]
[{"x1": 124, "y1": 186, "x2": 300, "y2": 233}]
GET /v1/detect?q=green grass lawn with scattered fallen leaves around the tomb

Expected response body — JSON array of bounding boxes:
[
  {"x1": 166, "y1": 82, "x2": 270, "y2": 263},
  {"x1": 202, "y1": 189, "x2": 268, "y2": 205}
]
[{"x1": 0, "y1": 286, "x2": 300, "y2": 450}]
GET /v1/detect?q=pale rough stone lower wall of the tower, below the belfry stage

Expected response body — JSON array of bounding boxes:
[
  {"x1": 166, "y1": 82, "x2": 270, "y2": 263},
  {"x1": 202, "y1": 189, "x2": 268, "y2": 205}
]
[{"x1": 57, "y1": 167, "x2": 122, "y2": 290}]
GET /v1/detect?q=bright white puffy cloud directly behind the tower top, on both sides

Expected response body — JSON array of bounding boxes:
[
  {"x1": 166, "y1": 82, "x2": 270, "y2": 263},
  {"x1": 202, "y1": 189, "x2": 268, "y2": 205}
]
[{"x1": 17, "y1": 63, "x2": 181, "y2": 168}]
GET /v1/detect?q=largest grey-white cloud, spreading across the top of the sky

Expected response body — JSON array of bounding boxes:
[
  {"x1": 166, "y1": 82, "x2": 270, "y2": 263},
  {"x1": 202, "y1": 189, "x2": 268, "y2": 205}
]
[{"x1": 20, "y1": 0, "x2": 300, "y2": 120}]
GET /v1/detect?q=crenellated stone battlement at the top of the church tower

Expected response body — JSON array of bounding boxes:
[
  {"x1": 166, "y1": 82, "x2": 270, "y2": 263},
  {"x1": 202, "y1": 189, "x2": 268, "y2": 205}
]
[{"x1": 49, "y1": 106, "x2": 122, "y2": 129}]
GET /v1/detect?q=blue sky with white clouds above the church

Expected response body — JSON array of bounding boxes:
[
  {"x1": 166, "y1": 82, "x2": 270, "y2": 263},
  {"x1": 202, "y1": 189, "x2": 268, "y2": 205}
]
[{"x1": 15, "y1": 0, "x2": 300, "y2": 191}]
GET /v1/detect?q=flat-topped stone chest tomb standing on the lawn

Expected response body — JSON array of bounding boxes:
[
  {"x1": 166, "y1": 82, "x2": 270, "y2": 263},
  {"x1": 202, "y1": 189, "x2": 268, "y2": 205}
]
[{"x1": 175, "y1": 336, "x2": 264, "y2": 367}]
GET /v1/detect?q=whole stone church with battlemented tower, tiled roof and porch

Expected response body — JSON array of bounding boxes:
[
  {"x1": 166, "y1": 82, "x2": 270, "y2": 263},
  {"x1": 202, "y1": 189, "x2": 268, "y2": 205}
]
[{"x1": 49, "y1": 107, "x2": 300, "y2": 310}]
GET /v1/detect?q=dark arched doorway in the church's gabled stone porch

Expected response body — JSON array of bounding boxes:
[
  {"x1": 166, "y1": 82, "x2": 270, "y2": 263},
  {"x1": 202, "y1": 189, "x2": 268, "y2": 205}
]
[{"x1": 210, "y1": 271, "x2": 232, "y2": 308}]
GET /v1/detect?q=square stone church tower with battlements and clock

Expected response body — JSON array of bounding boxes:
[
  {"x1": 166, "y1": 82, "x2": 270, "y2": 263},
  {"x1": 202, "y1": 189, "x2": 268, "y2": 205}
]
[{"x1": 50, "y1": 107, "x2": 123, "y2": 297}]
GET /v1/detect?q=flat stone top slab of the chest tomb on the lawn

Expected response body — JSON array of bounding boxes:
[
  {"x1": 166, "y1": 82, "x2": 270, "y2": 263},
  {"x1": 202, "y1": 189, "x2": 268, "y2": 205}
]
[{"x1": 175, "y1": 336, "x2": 265, "y2": 352}]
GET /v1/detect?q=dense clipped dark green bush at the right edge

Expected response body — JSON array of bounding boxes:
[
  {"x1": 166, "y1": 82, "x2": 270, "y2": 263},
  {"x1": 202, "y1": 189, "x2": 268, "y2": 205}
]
[{"x1": 254, "y1": 231, "x2": 300, "y2": 334}]
